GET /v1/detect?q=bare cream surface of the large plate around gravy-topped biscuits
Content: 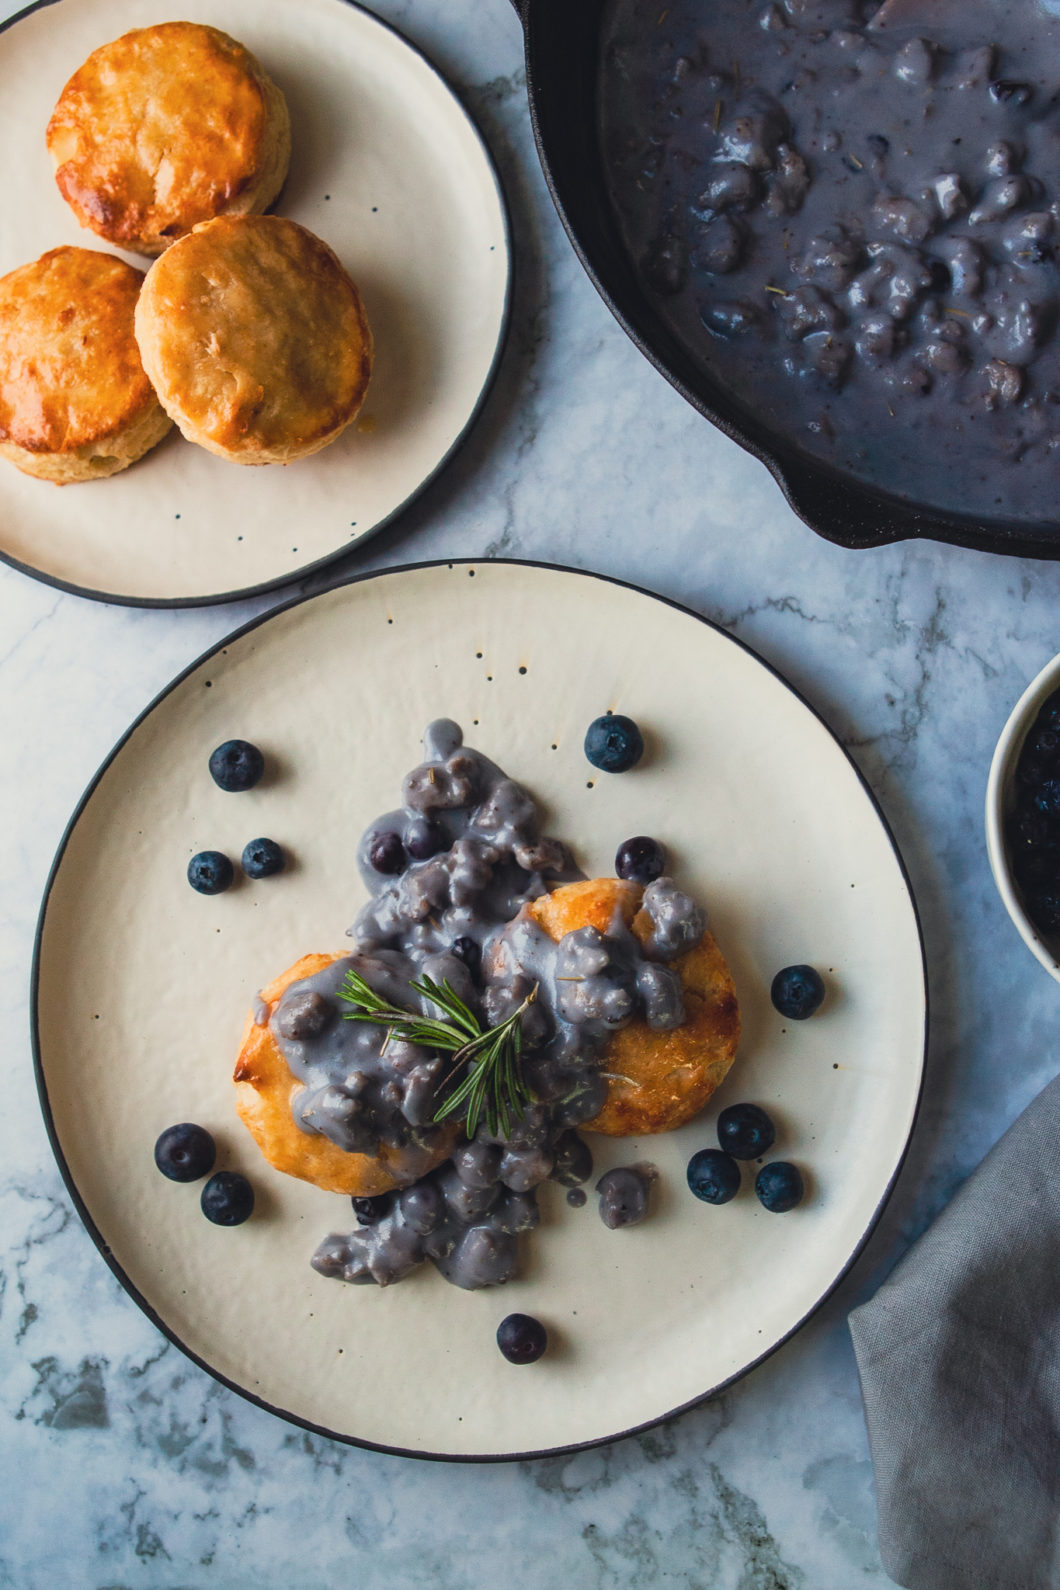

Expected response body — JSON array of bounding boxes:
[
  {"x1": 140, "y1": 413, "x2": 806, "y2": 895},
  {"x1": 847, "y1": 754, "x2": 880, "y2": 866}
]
[{"x1": 35, "y1": 563, "x2": 925, "y2": 1458}]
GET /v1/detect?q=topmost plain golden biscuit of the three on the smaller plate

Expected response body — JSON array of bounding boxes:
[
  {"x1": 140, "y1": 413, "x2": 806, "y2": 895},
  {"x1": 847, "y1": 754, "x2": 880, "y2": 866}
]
[{"x1": 46, "y1": 22, "x2": 291, "y2": 254}]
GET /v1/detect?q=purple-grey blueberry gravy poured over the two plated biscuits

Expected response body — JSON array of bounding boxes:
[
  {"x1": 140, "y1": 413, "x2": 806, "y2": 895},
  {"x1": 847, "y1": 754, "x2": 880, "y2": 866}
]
[{"x1": 270, "y1": 720, "x2": 706, "y2": 1289}]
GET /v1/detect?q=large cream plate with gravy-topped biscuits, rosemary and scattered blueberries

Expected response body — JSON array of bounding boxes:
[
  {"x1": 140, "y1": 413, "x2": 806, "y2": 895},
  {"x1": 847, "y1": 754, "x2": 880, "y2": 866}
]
[{"x1": 33, "y1": 561, "x2": 927, "y2": 1460}]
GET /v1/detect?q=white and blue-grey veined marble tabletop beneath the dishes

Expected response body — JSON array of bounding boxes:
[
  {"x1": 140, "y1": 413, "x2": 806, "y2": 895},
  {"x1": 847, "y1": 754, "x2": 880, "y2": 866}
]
[{"x1": 0, "y1": 0, "x2": 1060, "y2": 1590}]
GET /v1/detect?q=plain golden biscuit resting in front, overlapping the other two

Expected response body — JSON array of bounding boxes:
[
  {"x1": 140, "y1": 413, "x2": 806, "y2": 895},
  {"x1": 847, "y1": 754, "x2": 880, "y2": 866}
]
[{"x1": 135, "y1": 215, "x2": 372, "y2": 464}]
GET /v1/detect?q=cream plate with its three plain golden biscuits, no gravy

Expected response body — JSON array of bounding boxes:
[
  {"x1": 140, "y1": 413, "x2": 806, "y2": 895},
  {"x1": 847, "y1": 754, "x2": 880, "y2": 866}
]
[{"x1": 0, "y1": 0, "x2": 510, "y2": 606}]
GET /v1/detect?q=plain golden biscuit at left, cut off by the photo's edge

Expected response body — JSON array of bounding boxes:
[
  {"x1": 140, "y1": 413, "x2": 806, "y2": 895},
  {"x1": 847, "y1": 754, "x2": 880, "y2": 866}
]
[{"x1": 0, "y1": 248, "x2": 172, "y2": 485}]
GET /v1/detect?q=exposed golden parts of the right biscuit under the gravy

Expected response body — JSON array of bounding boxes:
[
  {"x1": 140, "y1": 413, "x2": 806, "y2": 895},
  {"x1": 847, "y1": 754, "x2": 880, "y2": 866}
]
[{"x1": 528, "y1": 878, "x2": 741, "y2": 1137}]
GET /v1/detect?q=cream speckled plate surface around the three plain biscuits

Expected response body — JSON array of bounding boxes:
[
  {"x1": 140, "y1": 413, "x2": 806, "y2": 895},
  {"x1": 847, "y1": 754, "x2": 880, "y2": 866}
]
[{"x1": 0, "y1": 0, "x2": 509, "y2": 606}]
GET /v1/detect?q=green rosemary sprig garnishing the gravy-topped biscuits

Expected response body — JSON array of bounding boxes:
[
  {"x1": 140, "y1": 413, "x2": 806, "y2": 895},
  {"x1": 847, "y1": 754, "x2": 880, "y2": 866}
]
[{"x1": 339, "y1": 971, "x2": 537, "y2": 1137}]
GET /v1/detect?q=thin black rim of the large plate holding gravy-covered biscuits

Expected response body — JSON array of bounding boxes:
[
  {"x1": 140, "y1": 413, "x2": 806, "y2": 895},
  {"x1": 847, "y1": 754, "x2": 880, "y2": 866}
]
[{"x1": 30, "y1": 558, "x2": 930, "y2": 1463}]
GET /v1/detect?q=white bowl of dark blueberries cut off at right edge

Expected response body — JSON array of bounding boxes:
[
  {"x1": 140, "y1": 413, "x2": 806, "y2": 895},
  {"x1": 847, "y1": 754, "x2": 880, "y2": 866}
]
[{"x1": 987, "y1": 657, "x2": 1060, "y2": 983}]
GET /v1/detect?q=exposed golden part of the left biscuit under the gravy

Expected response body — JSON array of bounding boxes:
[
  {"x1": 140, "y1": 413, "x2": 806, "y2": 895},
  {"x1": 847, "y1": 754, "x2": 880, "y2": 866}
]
[{"x1": 232, "y1": 954, "x2": 456, "y2": 1197}]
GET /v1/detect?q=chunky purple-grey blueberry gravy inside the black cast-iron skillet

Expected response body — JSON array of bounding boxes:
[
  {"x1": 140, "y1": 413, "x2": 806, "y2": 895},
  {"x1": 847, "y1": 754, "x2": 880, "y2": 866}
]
[{"x1": 599, "y1": 0, "x2": 1060, "y2": 523}]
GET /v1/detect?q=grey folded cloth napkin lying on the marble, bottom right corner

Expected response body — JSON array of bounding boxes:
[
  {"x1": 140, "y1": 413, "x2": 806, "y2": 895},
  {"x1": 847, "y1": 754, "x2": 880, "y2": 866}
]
[{"x1": 850, "y1": 1076, "x2": 1060, "y2": 1590}]
